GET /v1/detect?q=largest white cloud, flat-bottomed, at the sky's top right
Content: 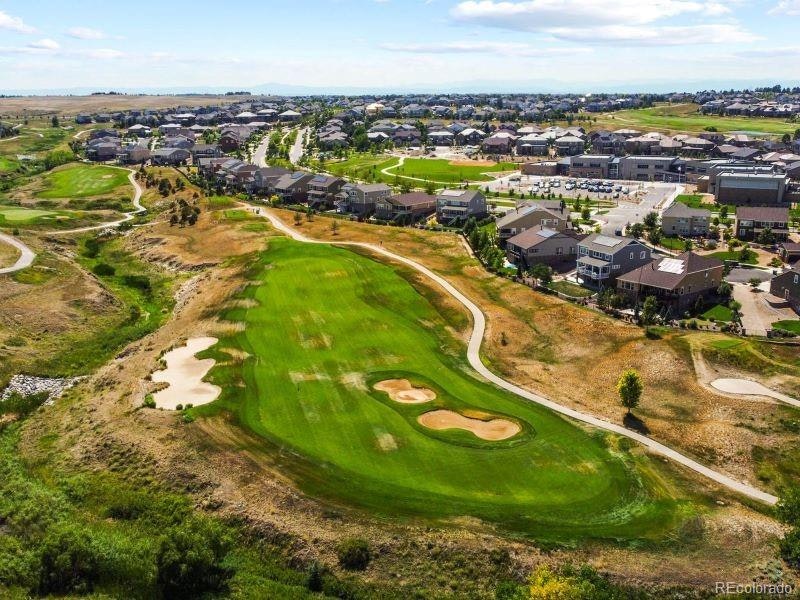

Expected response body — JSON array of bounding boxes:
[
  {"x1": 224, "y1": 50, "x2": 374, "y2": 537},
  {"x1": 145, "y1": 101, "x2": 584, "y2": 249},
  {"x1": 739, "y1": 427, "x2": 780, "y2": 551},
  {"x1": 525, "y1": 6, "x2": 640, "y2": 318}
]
[{"x1": 451, "y1": 0, "x2": 752, "y2": 46}]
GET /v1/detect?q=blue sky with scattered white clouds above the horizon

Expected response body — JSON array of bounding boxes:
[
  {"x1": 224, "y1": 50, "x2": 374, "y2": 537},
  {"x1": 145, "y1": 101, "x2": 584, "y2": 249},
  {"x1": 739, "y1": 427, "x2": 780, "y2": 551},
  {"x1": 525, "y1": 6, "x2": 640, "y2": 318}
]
[{"x1": 0, "y1": 0, "x2": 800, "y2": 91}]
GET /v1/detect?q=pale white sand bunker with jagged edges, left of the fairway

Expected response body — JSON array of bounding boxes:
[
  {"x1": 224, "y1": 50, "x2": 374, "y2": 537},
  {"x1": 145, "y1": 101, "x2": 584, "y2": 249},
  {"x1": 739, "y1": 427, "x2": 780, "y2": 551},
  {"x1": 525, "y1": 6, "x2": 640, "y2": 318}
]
[{"x1": 153, "y1": 337, "x2": 222, "y2": 410}]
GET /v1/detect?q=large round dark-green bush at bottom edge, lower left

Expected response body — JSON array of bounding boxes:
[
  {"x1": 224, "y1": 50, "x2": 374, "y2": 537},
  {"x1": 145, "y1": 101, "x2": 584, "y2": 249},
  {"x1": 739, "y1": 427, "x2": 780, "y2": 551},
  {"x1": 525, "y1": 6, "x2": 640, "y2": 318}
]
[{"x1": 156, "y1": 518, "x2": 233, "y2": 598}]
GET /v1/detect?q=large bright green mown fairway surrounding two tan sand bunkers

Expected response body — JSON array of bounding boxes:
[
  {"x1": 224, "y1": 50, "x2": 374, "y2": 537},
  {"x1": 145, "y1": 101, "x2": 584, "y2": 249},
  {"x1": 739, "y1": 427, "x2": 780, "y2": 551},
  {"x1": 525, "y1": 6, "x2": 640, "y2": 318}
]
[{"x1": 193, "y1": 238, "x2": 695, "y2": 541}]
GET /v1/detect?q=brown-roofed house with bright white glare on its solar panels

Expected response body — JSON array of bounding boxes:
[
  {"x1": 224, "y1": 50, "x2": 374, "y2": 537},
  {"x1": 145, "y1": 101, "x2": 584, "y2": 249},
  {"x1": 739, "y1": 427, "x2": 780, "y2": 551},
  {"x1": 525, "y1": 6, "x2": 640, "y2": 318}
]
[{"x1": 617, "y1": 252, "x2": 724, "y2": 315}]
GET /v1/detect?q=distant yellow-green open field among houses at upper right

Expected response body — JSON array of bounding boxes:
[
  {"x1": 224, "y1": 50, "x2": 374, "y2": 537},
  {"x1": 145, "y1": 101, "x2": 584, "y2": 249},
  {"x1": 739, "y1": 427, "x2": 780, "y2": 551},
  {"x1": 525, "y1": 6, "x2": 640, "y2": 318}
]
[{"x1": 592, "y1": 103, "x2": 800, "y2": 136}]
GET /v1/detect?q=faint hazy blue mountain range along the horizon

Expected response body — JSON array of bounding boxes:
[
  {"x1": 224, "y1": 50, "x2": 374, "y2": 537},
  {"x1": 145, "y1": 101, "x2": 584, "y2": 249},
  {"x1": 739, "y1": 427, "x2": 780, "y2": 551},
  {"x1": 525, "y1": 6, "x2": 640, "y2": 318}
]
[{"x1": 6, "y1": 79, "x2": 800, "y2": 96}]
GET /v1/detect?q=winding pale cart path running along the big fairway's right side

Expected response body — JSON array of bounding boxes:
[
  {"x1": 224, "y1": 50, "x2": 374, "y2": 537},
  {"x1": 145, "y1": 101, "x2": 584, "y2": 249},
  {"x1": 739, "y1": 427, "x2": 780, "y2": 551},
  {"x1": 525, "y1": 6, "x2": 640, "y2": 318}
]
[{"x1": 248, "y1": 209, "x2": 778, "y2": 504}]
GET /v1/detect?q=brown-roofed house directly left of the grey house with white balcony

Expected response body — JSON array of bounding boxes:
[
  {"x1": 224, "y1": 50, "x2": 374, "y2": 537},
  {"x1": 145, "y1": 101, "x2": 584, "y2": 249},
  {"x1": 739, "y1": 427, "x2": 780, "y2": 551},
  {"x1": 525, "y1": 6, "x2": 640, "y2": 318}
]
[{"x1": 506, "y1": 225, "x2": 585, "y2": 269}]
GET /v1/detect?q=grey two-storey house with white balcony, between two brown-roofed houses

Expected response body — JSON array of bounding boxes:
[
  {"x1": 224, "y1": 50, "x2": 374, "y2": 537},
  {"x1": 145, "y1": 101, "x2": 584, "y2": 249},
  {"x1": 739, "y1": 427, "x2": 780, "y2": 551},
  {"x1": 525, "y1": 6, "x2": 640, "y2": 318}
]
[{"x1": 577, "y1": 233, "x2": 652, "y2": 288}]
